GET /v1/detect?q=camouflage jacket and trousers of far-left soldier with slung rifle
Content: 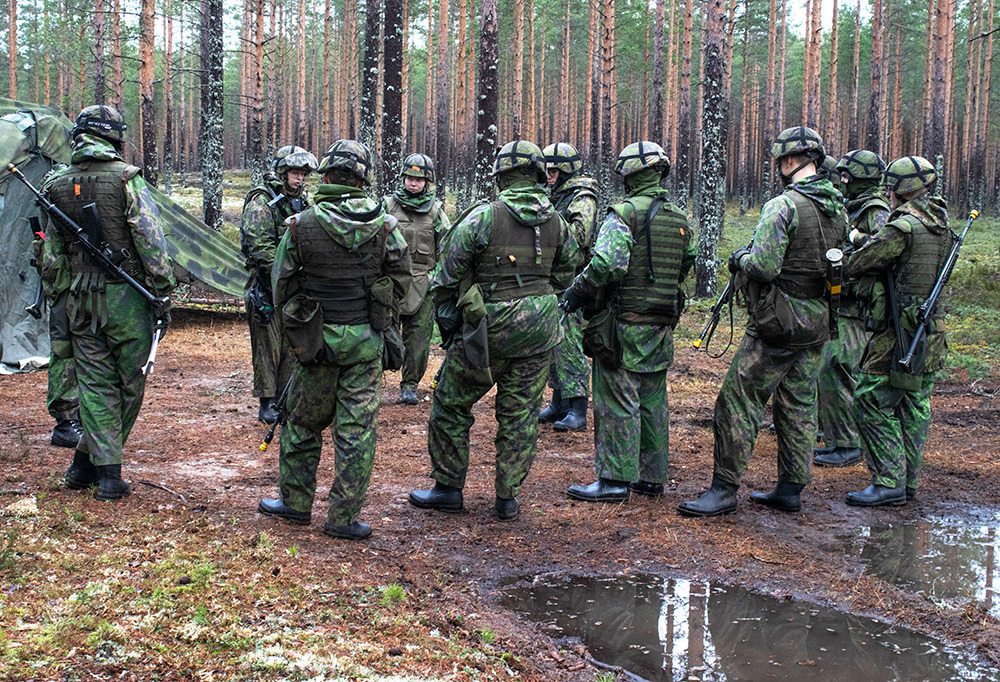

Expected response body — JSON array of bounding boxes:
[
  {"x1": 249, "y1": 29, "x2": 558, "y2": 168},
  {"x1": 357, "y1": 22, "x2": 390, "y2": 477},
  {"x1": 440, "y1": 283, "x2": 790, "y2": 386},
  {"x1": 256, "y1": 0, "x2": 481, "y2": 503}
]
[{"x1": 43, "y1": 133, "x2": 175, "y2": 467}]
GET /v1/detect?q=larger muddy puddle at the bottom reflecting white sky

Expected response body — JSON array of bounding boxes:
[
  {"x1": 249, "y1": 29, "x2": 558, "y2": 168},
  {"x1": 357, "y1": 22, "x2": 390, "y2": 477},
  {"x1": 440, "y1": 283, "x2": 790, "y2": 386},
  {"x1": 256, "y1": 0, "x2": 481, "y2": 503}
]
[{"x1": 501, "y1": 576, "x2": 1000, "y2": 682}]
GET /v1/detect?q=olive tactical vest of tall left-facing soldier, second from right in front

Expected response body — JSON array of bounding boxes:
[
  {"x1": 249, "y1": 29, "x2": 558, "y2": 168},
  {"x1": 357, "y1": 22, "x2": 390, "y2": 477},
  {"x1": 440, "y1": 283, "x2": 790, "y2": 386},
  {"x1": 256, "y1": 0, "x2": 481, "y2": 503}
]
[{"x1": 775, "y1": 188, "x2": 845, "y2": 298}]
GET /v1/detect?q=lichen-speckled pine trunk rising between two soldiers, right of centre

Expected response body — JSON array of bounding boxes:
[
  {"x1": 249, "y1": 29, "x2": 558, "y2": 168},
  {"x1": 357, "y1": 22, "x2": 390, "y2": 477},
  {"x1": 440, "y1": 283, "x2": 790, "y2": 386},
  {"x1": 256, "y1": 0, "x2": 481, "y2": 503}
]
[{"x1": 695, "y1": 0, "x2": 728, "y2": 297}]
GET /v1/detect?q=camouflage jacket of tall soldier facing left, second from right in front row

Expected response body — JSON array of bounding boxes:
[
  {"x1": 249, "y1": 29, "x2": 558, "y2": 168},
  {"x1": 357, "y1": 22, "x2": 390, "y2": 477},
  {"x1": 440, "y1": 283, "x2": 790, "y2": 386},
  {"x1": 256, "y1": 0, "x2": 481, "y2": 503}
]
[{"x1": 740, "y1": 174, "x2": 847, "y2": 336}]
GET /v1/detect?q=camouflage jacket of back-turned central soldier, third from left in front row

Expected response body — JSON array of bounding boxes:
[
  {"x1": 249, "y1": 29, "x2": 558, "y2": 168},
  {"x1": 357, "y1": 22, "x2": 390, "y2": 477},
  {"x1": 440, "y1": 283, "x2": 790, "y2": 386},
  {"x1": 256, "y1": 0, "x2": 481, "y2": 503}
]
[{"x1": 431, "y1": 181, "x2": 581, "y2": 357}]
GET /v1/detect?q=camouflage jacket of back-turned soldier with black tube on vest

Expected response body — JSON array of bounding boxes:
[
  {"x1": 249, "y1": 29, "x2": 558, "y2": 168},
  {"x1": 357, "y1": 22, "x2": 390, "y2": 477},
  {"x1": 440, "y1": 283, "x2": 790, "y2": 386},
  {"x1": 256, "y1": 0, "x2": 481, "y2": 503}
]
[{"x1": 572, "y1": 173, "x2": 697, "y2": 372}]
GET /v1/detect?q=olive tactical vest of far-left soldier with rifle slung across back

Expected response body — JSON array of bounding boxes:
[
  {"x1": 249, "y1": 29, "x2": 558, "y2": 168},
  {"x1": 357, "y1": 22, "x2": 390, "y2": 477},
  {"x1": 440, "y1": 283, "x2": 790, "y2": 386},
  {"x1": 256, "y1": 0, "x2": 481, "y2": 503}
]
[{"x1": 49, "y1": 160, "x2": 144, "y2": 282}]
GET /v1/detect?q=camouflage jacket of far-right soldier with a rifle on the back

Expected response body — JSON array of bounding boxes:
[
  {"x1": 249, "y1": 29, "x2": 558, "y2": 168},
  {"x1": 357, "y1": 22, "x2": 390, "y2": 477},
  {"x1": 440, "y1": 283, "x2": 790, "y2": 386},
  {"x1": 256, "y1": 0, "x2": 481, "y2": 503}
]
[{"x1": 847, "y1": 194, "x2": 948, "y2": 374}]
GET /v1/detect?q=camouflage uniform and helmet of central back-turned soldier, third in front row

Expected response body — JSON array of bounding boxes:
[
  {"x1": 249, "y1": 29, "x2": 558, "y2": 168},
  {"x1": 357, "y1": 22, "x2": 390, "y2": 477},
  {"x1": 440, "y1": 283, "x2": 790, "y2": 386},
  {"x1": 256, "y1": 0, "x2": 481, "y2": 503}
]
[{"x1": 426, "y1": 142, "x2": 580, "y2": 506}]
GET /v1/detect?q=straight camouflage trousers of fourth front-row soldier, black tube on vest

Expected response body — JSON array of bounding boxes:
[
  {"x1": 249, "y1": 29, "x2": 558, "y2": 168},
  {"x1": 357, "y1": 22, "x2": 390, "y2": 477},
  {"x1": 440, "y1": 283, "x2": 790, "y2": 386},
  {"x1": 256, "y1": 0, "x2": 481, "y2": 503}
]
[{"x1": 594, "y1": 362, "x2": 670, "y2": 483}]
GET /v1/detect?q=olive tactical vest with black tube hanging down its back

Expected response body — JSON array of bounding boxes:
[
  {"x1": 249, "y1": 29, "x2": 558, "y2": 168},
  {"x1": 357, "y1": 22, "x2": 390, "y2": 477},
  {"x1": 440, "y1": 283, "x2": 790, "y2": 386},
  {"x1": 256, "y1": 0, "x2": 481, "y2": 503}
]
[{"x1": 616, "y1": 196, "x2": 691, "y2": 325}]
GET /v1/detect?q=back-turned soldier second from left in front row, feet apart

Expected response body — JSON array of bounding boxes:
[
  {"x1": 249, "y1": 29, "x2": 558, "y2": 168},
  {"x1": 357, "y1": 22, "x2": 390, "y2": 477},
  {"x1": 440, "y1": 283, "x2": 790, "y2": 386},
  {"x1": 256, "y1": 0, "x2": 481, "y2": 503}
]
[{"x1": 257, "y1": 140, "x2": 410, "y2": 540}]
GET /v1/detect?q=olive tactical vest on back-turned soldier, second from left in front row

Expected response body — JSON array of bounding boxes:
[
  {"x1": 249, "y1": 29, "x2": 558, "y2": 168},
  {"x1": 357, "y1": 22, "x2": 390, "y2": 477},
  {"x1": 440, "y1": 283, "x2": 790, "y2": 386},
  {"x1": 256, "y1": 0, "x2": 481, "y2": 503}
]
[{"x1": 292, "y1": 209, "x2": 385, "y2": 324}]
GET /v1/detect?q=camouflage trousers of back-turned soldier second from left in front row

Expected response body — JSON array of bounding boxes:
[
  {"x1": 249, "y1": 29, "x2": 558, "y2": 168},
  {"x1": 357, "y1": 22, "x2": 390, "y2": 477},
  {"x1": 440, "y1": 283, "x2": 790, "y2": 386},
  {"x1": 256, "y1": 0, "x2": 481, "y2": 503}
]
[{"x1": 278, "y1": 358, "x2": 382, "y2": 526}]
